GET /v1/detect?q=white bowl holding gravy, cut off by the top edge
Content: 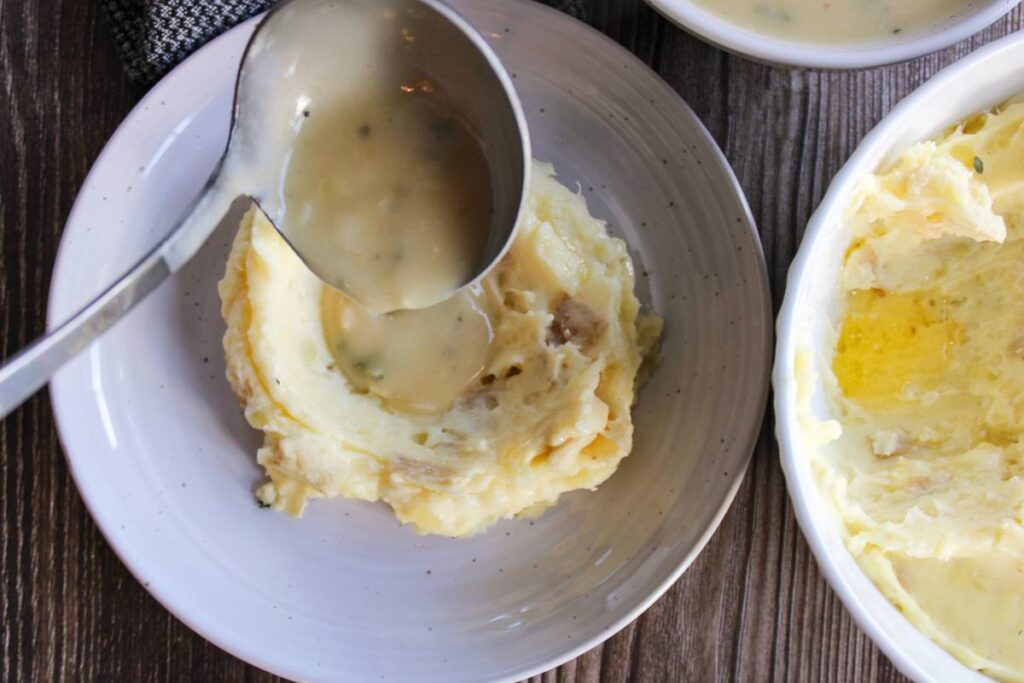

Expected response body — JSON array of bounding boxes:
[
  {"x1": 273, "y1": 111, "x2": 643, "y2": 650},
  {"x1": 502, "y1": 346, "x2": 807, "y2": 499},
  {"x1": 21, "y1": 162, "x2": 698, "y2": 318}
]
[{"x1": 647, "y1": 0, "x2": 1020, "y2": 69}]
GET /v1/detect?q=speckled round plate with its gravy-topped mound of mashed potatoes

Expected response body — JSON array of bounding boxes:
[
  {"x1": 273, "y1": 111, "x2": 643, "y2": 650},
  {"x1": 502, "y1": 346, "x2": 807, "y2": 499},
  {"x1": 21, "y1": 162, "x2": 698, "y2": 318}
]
[{"x1": 49, "y1": 0, "x2": 771, "y2": 683}]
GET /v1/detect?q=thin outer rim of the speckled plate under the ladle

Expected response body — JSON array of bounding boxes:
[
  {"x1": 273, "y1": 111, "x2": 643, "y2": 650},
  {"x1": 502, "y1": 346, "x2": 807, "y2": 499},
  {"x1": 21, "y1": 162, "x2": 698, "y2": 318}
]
[{"x1": 47, "y1": 2, "x2": 772, "y2": 681}]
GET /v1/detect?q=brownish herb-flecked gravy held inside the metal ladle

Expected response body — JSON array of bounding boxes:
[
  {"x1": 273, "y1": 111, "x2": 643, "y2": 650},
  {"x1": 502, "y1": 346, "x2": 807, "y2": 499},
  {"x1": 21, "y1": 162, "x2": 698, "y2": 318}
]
[{"x1": 281, "y1": 78, "x2": 490, "y2": 311}]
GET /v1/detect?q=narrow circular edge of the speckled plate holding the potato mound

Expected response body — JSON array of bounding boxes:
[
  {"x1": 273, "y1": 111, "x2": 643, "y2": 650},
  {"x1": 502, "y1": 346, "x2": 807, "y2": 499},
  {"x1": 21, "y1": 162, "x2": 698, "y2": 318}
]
[{"x1": 46, "y1": 3, "x2": 772, "y2": 681}]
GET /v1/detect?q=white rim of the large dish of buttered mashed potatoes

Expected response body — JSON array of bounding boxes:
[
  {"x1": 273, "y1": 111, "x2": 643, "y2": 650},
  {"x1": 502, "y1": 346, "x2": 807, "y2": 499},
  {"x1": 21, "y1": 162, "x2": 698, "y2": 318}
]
[{"x1": 772, "y1": 33, "x2": 1024, "y2": 683}]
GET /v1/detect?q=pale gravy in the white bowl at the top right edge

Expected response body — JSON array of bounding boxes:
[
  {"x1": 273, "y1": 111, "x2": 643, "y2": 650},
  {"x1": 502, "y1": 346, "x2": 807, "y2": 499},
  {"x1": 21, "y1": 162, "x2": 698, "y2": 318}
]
[{"x1": 693, "y1": 0, "x2": 968, "y2": 43}]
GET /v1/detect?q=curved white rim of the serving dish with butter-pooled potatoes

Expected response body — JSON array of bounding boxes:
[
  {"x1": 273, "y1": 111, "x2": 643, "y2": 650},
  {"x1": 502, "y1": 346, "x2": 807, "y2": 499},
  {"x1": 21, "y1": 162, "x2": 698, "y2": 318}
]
[{"x1": 772, "y1": 33, "x2": 1024, "y2": 681}]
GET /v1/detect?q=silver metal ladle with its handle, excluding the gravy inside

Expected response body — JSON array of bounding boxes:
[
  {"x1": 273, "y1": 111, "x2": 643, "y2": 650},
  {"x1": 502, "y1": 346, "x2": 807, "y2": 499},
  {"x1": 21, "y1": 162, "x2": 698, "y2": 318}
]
[{"x1": 0, "y1": 0, "x2": 530, "y2": 419}]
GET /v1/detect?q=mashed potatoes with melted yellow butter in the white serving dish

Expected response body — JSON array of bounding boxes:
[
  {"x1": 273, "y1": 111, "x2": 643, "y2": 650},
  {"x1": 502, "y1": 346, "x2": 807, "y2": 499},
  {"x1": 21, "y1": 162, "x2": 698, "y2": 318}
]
[{"x1": 815, "y1": 101, "x2": 1024, "y2": 681}]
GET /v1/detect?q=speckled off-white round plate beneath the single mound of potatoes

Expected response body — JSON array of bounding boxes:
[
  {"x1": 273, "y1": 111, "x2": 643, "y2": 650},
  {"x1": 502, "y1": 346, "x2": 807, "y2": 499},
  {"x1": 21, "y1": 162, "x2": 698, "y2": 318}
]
[{"x1": 49, "y1": 0, "x2": 771, "y2": 683}]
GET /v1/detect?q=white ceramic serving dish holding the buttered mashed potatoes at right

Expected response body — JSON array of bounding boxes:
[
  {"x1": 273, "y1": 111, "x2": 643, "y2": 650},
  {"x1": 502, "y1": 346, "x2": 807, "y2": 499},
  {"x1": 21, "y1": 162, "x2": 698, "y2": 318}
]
[{"x1": 773, "y1": 33, "x2": 1024, "y2": 683}]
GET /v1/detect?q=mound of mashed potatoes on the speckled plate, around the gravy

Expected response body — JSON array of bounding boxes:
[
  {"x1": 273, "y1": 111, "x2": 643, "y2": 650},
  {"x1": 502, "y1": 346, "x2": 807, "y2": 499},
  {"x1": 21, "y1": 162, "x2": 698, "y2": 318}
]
[{"x1": 220, "y1": 165, "x2": 660, "y2": 537}]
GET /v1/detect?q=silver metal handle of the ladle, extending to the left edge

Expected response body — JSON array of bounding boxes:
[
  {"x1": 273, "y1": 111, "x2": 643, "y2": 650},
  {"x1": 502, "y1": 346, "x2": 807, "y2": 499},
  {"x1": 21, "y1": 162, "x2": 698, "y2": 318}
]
[{"x1": 0, "y1": 172, "x2": 234, "y2": 420}]
